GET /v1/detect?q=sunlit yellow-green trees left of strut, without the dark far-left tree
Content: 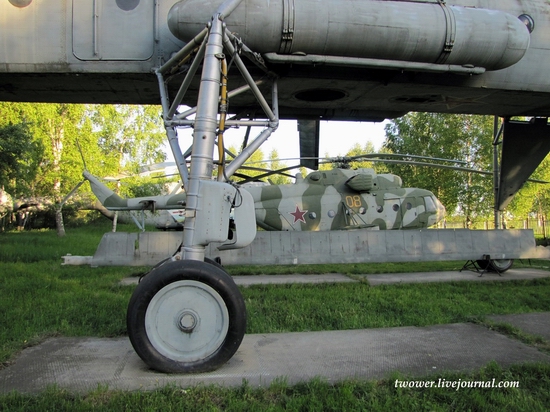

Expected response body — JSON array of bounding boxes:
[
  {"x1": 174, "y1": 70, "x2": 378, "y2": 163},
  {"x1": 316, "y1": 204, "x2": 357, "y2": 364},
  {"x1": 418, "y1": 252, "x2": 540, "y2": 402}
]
[{"x1": 0, "y1": 103, "x2": 165, "y2": 235}]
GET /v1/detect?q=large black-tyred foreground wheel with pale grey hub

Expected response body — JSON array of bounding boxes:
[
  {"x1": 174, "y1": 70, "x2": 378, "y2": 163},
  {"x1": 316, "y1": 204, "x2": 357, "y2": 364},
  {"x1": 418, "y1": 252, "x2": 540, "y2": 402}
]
[{"x1": 126, "y1": 260, "x2": 246, "y2": 373}]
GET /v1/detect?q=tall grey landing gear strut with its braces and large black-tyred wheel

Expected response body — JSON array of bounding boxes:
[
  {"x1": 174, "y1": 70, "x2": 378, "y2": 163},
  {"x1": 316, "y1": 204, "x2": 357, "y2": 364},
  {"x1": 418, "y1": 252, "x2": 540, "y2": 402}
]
[{"x1": 127, "y1": 0, "x2": 272, "y2": 373}]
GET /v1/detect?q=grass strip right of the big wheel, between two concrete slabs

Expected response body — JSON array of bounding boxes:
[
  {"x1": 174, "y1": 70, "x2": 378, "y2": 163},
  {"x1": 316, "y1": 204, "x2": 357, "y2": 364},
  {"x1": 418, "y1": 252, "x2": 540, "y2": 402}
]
[{"x1": 243, "y1": 278, "x2": 550, "y2": 333}]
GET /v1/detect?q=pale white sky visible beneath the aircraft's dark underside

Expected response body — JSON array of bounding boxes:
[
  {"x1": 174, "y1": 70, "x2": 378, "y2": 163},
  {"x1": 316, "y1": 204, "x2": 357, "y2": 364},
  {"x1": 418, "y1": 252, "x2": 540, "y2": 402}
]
[{"x1": 169, "y1": 120, "x2": 386, "y2": 160}]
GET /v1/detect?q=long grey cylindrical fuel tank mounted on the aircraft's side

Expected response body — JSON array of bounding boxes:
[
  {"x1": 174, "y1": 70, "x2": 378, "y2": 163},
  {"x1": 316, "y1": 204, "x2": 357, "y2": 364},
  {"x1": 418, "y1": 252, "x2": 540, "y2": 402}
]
[{"x1": 168, "y1": 0, "x2": 530, "y2": 70}]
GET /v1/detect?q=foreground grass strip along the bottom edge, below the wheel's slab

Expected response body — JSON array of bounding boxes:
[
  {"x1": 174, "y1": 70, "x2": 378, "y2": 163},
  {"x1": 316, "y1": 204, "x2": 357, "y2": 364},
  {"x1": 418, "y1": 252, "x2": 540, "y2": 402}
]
[{"x1": 0, "y1": 363, "x2": 550, "y2": 412}]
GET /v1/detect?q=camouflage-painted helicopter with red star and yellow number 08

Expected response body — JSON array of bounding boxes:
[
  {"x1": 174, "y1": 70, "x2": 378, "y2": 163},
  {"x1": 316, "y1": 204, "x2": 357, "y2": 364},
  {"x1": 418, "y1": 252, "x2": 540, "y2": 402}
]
[{"x1": 83, "y1": 163, "x2": 445, "y2": 231}]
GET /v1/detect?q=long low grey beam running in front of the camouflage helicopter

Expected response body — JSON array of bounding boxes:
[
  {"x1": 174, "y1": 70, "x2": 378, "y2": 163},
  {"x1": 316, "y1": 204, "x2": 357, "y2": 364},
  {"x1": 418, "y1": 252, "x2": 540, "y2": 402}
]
[{"x1": 69, "y1": 229, "x2": 550, "y2": 266}]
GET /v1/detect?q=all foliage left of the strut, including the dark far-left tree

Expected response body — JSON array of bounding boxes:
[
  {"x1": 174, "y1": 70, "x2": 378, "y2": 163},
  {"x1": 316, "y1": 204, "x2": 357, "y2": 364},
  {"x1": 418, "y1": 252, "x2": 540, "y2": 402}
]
[{"x1": 0, "y1": 102, "x2": 165, "y2": 229}]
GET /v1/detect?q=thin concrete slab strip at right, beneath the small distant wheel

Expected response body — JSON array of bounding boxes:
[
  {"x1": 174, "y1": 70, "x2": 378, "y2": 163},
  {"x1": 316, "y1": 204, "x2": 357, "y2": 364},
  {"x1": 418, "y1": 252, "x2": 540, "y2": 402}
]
[{"x1": 362, "y1": 268, "x2": 550, "y2": 286}]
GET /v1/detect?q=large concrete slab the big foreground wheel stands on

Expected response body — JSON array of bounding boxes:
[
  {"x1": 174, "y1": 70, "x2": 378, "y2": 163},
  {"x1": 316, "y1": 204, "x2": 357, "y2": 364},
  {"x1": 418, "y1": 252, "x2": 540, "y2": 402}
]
[{"x1": 0, "y1": 322, "x2": 550, "y2": 393}]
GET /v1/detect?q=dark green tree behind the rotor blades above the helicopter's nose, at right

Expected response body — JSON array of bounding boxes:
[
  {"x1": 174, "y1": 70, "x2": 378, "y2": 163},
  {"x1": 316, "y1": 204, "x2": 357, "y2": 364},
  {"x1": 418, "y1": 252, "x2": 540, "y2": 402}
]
[{"x1": 384, "y1": 113, "x2": 493, "y2": 224}]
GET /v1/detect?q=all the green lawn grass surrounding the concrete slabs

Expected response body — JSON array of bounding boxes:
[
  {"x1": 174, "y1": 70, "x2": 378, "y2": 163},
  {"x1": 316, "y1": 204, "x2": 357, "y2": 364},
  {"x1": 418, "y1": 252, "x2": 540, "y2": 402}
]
[{"x1": 0, "y1": 220, "x2": 550, "y2": 410}]
